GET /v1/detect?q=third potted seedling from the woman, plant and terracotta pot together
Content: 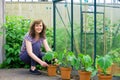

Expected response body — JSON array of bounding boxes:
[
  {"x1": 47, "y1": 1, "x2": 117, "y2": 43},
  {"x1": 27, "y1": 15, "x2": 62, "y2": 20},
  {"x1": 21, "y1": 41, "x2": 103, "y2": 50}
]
[{"x1": 75, "y1": 53, "x2": 97, "y2": 80}]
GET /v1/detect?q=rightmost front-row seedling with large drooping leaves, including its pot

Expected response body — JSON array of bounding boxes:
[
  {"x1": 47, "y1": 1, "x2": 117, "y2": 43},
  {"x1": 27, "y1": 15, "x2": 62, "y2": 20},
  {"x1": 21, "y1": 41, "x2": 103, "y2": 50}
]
[{"x1": 97, "y1": 54, "x2": 113, "y2": 80}]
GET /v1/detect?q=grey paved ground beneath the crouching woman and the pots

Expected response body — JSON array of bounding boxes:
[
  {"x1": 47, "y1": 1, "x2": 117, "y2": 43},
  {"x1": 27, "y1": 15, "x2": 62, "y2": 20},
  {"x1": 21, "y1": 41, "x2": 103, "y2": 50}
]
[{"x1": 0, "y1": 69, "x2": 120, "y2": 80}]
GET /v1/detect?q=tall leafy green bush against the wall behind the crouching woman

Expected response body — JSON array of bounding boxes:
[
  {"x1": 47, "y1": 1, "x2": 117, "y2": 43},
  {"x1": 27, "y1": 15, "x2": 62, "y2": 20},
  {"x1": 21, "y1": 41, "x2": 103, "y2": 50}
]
[{"x1": 0, "y1": 16, "x2": 52, "y2": 68}]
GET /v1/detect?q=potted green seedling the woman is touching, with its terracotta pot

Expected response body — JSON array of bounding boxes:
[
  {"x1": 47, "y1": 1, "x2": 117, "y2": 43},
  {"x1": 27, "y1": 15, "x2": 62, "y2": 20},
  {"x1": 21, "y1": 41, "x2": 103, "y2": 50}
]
[{"x1": 43, "y1": 51, "x2": 58, "y2": 76}]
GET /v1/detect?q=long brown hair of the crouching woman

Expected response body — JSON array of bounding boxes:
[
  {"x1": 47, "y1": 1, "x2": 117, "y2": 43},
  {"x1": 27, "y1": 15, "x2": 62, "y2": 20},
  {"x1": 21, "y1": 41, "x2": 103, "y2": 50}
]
[{"x1": 29, "y1": 19, "x2": 46, "y2": 38}]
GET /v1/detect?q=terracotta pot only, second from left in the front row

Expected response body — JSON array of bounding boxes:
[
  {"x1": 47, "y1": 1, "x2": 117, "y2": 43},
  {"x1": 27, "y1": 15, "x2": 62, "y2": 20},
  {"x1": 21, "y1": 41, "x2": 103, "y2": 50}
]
[{"x1": 60, "y1": 67, "x2": 72, "y2": 80}]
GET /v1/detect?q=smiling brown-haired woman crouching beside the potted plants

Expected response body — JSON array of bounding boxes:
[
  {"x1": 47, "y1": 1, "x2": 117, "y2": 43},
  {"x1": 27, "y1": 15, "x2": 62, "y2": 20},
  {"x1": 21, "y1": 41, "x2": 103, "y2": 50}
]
[{"x1": 20, "y1": 20, "x2": 51, "y2": 74}]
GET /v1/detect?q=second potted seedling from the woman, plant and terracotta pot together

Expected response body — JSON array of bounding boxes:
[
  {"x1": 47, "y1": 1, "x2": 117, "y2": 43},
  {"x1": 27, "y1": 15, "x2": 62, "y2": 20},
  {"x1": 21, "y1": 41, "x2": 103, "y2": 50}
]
[{"x1": 58, "y1": 50, "x2": 76, "y2": 80}]
